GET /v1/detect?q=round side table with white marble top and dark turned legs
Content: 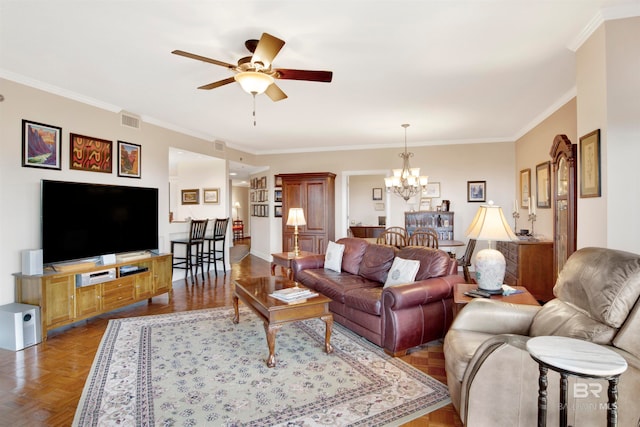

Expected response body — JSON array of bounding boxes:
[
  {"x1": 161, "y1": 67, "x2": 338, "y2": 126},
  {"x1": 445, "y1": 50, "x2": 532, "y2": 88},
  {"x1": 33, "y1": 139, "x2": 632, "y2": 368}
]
[{"x1": 527, "y1": 336, "x2": 627, "y2": 427}]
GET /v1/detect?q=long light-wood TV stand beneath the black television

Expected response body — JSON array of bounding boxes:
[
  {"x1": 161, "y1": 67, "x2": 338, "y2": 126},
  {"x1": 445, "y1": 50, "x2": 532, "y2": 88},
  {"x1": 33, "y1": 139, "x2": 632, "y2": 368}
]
[{"x1": 14, "y1": 254, "x2": 172, "y2": 340}]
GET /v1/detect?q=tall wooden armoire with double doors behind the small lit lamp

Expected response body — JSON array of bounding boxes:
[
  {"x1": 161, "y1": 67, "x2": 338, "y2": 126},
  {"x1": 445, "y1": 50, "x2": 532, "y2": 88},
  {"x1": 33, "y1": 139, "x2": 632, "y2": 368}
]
[{"x1": 277, "y1": 172, "x2": 336, "y2": 254}]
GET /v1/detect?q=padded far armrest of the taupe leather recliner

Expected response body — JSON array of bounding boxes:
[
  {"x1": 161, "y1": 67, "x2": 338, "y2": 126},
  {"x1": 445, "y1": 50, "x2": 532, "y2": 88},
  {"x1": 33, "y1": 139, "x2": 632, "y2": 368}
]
[{"x1": 451, "y1": 298, "x2": 542, "y2": 335}]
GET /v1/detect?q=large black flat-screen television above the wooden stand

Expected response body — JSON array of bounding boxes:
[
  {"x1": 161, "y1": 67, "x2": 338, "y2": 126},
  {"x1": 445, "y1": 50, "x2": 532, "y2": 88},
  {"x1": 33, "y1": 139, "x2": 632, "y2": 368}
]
[{"x1": 42, "y1": 180, "x2": 158, "y2": 264}]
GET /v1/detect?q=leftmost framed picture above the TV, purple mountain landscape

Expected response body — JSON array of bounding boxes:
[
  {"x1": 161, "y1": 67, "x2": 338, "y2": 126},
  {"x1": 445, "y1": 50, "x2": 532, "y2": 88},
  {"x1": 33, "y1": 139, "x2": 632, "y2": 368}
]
[{"x1": 22, "y1": 120, "x2": 62, "y2": 170}]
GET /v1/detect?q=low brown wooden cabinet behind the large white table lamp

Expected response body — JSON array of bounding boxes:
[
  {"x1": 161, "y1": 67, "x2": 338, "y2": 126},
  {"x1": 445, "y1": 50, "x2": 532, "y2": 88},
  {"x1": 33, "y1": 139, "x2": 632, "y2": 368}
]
[{"x1": 496, "y1": 240, "x2": 554, "y2": 302}]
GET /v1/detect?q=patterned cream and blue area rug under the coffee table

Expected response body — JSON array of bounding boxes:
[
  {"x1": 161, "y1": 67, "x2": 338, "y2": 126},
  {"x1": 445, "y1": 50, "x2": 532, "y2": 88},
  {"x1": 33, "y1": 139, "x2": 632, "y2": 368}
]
[{"x1": 73, "y1": 306, "x2": 451, "y2": 427}]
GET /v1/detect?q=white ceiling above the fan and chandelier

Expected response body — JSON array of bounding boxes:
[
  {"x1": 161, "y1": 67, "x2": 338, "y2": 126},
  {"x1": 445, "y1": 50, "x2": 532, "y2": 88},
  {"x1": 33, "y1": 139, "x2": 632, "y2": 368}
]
[{"x1": 0, "y1": 0, "x2": 640, "y2": 158}]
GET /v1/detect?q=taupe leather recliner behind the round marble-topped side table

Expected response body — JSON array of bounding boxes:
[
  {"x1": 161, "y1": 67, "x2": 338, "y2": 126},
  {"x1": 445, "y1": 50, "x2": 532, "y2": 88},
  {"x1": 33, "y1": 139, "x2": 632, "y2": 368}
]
[{"x1": 444, "y1": 248, "x2": 640, "y2": 427}]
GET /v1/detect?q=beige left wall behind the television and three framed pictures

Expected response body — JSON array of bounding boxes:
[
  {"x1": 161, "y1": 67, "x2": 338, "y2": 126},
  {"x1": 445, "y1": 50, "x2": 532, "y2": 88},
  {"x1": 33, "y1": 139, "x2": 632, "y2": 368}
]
[{"x1": 0, "y1": 79, "x2": 229, "y2": 305}]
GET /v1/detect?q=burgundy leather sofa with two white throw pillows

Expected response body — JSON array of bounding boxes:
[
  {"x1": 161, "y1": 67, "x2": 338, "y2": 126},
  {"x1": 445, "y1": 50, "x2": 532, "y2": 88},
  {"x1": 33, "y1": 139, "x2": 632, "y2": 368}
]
[{"x1": 292, "y1": 238, "x2": 464, "y2": 356}]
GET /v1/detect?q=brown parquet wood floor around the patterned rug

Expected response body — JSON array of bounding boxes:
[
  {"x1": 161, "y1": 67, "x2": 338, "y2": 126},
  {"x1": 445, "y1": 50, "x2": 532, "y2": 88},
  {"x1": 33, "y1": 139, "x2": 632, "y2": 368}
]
[{"x1": 0, "y1": 242, "x2": 462, "y2": 427}]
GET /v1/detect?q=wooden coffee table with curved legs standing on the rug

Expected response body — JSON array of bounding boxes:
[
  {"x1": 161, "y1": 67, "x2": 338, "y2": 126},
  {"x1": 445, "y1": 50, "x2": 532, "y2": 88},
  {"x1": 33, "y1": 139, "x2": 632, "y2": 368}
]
[{"x1": 233, "y1": 276, "x2": 333, "y2": 368}]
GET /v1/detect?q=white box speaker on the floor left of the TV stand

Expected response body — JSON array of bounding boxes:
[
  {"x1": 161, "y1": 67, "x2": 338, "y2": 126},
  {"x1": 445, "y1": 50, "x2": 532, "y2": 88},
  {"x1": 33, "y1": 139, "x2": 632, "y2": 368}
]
[{"x1": 0, "y1": 303, "x2": 42, "y2": 351}]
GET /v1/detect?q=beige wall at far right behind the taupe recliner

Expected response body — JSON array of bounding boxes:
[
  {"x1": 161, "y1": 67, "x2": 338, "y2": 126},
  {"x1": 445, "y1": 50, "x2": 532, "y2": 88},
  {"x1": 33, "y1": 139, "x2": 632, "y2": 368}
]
[{"x1": 577, "y1": 17, "x2": 640, "y2": 253}]
